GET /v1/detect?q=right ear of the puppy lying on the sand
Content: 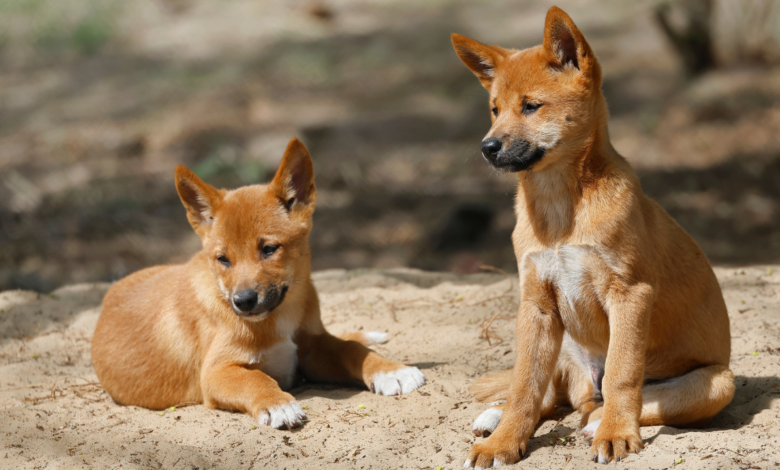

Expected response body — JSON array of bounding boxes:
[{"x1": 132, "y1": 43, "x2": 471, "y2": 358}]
[{"x1": 271, "y1": 138, "x2": 317, "y2": 211}]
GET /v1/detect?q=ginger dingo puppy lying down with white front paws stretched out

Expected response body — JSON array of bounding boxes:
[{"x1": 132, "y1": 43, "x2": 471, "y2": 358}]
[{"x1": 92, "y1": 139, "x2": 425, "y2": 428}]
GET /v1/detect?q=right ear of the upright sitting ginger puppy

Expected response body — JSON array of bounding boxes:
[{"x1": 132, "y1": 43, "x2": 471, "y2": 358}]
[{"x1": 542, "y1": 7, "x2": 601, "y2": 82}]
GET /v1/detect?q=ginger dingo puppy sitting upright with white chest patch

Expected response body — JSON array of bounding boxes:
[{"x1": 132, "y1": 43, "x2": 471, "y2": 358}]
[{"x1": 452, "y1": 7, "x2": 734, "y2": 467}]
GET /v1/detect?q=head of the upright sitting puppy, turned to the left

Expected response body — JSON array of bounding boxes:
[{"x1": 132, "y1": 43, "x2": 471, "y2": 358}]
[{"x1": 452, "y1": 7, "x2": 606, "y2": 172}]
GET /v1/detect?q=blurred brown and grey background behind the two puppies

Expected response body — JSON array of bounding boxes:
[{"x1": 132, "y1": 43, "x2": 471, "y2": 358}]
[{"x1": 0, "y1": 0, "x2": 780, "y2": 292}]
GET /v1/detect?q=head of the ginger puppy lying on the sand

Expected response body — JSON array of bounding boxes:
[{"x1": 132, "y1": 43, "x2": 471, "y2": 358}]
[{"x1": 176, "y1": 139, "x2": 317, "y2": 321}]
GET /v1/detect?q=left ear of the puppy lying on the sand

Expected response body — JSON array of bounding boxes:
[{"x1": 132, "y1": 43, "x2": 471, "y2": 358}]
[{"x1": 176, "y1": 165, "x2": 223, "y2": 238}]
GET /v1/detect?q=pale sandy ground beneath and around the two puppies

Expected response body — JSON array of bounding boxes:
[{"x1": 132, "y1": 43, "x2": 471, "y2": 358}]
[{"x1": 0, "y1": 266, "x2": 780, "y2": 469}]
